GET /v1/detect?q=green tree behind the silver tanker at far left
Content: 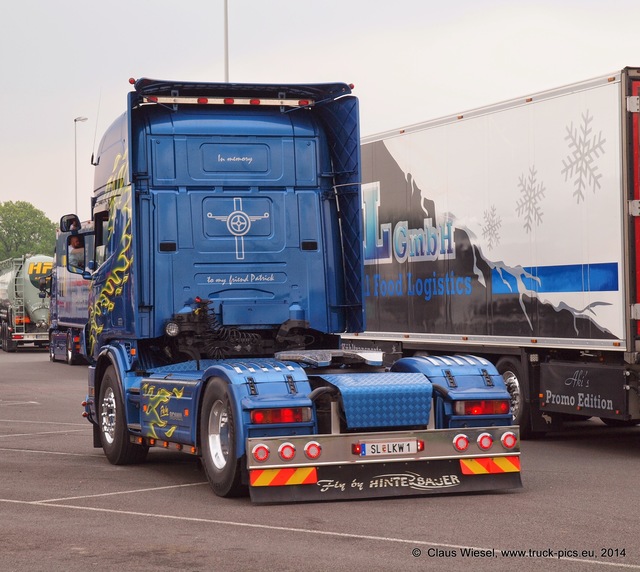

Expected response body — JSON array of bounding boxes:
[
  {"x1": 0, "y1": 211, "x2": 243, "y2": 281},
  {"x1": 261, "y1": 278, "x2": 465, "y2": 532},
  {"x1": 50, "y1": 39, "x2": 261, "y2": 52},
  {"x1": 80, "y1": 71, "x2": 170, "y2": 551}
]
[{"x1": 0, "y1": 201, "x2": 56, "y2": 260}]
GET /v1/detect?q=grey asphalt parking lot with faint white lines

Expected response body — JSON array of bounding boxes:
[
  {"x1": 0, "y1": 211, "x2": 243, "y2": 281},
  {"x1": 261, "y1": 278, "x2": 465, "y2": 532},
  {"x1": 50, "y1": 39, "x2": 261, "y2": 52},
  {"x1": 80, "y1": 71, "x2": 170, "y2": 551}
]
[{"x1": 0, "y1": 350, "x2": 640, "y2": 572}]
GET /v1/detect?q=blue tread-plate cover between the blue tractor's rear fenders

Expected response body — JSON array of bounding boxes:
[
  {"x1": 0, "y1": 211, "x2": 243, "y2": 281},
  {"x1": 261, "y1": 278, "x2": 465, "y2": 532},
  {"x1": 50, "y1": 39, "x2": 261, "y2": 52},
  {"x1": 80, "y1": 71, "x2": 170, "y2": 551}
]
[{"x1": 322, "y1": 373, "x2": 432, "y2": 429}]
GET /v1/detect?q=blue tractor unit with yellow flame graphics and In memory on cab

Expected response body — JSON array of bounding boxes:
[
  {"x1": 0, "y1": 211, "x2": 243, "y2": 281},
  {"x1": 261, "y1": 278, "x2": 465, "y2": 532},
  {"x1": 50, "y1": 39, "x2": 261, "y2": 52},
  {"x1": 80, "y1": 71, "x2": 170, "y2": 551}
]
[{"x1": 61, "y1": 79, "x2": 521, "y2": 502}]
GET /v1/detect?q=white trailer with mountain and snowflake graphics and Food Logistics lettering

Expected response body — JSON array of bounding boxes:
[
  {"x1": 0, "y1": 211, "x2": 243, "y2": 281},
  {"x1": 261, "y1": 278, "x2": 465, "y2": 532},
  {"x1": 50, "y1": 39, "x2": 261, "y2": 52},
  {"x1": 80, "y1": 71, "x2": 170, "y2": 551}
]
[{"x1": 344, "y1": 68, "x2": 640, "y2": 435}]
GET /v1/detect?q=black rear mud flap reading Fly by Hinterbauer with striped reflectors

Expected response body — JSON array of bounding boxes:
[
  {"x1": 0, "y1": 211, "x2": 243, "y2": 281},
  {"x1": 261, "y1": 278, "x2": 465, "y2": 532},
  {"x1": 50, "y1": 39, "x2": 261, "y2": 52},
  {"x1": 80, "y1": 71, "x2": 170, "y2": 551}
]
[{"x1": 249, "y1": 457, "x2": 522, "y2": 503}]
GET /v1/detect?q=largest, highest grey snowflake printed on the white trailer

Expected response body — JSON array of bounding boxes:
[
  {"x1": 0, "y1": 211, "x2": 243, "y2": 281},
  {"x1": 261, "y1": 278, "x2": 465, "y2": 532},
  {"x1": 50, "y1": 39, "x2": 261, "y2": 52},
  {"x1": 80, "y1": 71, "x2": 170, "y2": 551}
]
[{"x1": 561, "y1": 109, "x2": 607, "y2": 203}]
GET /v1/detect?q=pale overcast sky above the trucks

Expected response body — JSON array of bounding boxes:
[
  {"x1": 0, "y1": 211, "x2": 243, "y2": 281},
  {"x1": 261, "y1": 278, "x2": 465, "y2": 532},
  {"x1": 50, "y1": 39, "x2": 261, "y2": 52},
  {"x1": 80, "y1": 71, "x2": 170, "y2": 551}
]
[{"x1": 0, "y1": 0, "x2": 640, "y2": 222}]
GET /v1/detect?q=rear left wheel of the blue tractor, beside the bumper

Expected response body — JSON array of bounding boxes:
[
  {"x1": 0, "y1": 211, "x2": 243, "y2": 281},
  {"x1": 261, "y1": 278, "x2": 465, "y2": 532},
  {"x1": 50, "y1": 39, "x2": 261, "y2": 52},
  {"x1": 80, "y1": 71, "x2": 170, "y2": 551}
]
[{"x1": 200, "y1": 377, "x2": 246, "y2": 497}]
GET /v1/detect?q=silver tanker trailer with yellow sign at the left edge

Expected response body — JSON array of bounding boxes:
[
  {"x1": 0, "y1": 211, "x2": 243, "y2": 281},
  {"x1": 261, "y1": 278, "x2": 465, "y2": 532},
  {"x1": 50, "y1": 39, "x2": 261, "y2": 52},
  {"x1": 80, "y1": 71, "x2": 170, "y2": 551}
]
[{"x1": 0, "y1": 255, "x2": 53, "y2": 352}]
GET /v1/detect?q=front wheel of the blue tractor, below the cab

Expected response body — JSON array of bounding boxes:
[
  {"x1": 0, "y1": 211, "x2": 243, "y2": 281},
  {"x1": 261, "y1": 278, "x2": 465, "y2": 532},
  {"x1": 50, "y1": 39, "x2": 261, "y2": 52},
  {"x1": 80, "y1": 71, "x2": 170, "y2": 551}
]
[{"x1": 97, "y1": 365, "x2": 149, "y2": 465}]
